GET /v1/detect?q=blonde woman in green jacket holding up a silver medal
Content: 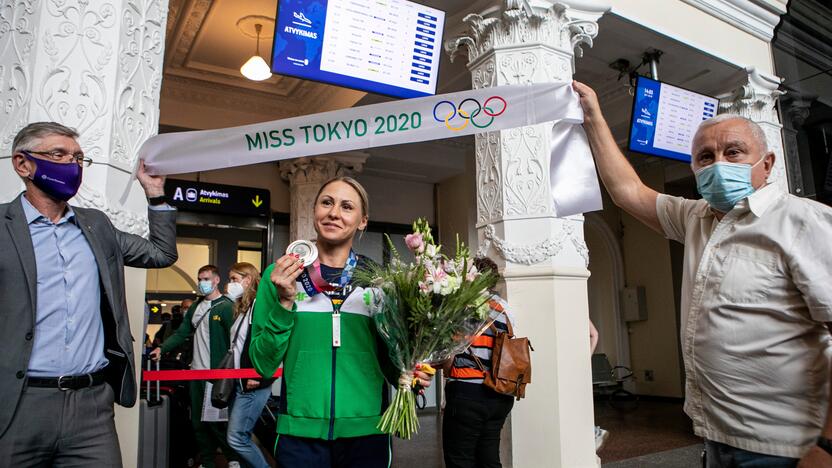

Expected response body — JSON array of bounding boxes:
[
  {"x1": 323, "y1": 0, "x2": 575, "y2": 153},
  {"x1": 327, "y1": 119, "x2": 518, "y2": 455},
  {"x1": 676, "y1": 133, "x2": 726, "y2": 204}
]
[{"x1": 250, "y1": 177, "x2": 430, "y2": 468}]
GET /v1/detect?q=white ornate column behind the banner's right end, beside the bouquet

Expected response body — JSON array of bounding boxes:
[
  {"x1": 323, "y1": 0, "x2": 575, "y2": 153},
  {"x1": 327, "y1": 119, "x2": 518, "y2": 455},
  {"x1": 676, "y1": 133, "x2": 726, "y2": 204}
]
[{"x1": 446, "y1": 0, "x2": 608, "y2": 467}]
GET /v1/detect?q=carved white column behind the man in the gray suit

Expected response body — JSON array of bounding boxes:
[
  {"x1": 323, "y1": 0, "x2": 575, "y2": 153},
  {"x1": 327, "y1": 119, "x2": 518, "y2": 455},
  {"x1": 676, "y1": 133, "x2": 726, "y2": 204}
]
[{"x1": 0, "y1": 0, "x2": 168, "y2": 466}]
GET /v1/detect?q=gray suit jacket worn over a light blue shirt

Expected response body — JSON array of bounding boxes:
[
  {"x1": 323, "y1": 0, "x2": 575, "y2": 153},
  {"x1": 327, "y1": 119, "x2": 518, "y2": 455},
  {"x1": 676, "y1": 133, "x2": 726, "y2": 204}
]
[{"x1": 0, "y1": 194, "x2": 177, "y2": 436}]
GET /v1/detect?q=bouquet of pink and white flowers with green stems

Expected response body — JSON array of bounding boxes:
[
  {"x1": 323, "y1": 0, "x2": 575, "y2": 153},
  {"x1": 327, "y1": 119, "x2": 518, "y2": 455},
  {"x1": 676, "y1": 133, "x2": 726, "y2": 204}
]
[{"x1": 355, "y1": 218, "x2": 496, "y2": 439}]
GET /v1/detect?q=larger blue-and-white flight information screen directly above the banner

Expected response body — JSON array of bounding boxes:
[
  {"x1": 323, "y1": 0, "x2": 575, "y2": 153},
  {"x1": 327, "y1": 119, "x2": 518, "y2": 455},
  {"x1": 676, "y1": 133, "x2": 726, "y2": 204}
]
[{"x1": 272, "y1": 0, "x2": 445, "y2": 98}]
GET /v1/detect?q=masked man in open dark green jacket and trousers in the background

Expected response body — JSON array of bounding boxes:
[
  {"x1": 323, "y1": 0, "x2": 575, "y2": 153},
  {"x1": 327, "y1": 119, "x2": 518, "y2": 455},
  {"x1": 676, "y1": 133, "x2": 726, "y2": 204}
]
[{"x1": 150, "y1": 265, "x2": 239, "y2": 467}]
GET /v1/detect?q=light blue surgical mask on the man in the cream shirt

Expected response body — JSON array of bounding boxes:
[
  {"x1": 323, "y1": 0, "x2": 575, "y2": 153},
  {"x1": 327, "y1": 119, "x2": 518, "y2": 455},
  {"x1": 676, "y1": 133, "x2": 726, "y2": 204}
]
[{"x1": 694, "y1": 155, "x2": 766, "y2": 213}]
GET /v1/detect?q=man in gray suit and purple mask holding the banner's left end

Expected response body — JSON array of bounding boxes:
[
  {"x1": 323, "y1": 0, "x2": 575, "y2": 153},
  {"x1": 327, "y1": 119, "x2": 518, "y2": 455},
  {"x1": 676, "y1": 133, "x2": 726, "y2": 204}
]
[{"x1": 0, "y1": 122, "x2": 177, "y2": 467}]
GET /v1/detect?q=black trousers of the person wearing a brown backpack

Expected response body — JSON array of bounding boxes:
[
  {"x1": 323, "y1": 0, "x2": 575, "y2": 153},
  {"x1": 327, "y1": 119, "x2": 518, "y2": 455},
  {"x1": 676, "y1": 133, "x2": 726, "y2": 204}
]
[{"x1": 442, "y1": 382, "x2": 514, "y2": 468}]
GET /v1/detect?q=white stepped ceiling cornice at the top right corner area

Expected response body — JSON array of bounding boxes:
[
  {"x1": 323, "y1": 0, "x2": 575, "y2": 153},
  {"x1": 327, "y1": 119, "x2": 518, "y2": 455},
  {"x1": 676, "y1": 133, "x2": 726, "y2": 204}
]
[{"x1": 682, "y1": 0, "x2": 787, "y2": 42}]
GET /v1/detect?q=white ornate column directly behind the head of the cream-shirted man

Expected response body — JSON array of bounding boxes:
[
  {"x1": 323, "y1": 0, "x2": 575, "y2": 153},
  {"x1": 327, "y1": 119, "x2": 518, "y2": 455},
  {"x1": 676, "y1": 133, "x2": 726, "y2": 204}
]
[{"x1": 719, "y1": 67, "x2": 789, "y2": 192}]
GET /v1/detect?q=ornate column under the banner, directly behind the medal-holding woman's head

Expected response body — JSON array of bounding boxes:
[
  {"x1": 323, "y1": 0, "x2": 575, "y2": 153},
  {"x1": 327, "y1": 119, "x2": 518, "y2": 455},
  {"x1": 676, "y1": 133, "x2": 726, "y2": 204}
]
[{"x1": 278, "y1": 151, "x2": 369, "y2": 241}]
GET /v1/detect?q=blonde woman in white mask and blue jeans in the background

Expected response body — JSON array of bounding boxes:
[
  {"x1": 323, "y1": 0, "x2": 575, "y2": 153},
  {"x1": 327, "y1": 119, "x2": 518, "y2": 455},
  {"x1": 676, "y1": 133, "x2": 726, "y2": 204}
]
[{"x1": 226, "y1": 262, "x2": 274, "y2": 468}]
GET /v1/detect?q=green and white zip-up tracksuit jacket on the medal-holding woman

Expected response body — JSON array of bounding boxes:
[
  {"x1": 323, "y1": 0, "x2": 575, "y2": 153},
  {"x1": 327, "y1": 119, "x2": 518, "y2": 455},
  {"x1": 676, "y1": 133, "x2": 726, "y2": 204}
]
[{"x1": 249, "y1": 264, "x2": 398, "y2": 440}]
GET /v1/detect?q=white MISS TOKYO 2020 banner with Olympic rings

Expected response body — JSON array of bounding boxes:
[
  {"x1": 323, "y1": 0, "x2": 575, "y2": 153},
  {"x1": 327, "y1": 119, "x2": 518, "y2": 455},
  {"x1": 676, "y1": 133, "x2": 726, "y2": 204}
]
[{"x1": 139, "y1": 83, "x2": 601, "y2": 217}]
